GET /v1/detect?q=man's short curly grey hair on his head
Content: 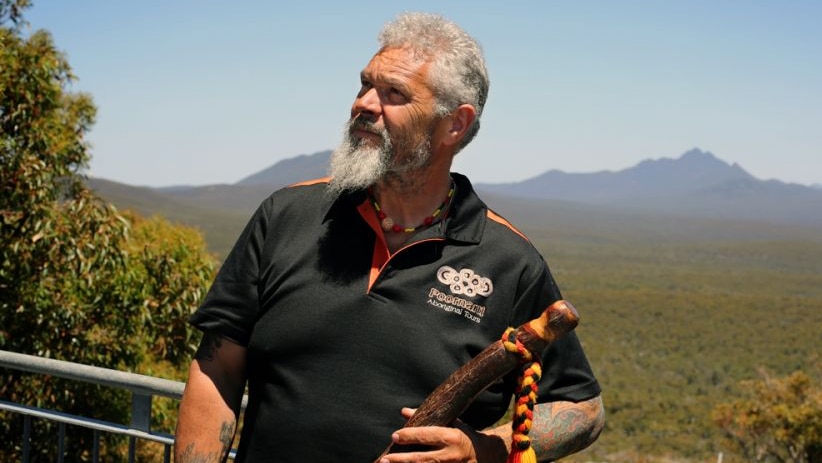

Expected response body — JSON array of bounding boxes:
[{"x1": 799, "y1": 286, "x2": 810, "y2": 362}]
[{"x1": 379, "y1": 13, "x2": 490, "y2": 149}]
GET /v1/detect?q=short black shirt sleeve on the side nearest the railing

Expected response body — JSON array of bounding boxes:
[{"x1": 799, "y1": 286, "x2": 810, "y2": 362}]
[{"x1": 189, "y1": 201, "x2": 269, "y2": 346}]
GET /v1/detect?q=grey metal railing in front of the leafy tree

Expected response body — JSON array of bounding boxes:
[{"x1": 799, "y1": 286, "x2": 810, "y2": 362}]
[{"x1": 0, "y1": 350, "x2": 241, "y2": 463}]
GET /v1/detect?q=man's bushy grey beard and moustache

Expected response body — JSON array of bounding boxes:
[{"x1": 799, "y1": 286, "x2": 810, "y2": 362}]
[{"x1": 328, "y1": 121, "x2": 433, "y2": 196}]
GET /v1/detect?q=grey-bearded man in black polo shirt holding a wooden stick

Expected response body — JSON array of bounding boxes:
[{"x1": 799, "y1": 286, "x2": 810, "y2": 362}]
[{"x1": 175, "y1": 13, "x2": 603, "y2": 463}]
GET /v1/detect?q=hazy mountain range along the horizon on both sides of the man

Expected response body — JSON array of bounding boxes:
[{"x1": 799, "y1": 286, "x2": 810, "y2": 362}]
[{"x1": 89, "y1": 148, "x2": 822, "y2": 253}]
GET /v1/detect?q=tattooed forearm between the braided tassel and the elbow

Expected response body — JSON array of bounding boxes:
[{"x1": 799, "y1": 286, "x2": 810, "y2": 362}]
[{"x1": 531, "y1": 398, "x2": 604, "y2": 461}]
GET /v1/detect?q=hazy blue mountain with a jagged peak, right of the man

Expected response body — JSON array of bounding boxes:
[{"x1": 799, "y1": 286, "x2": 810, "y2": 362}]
[{"x1": 477, "y1": 148, "x2": 822, "y2": 225}]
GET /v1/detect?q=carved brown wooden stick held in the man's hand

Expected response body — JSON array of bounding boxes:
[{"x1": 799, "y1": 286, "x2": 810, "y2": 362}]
[{"x1": 374, "y1": 300, "x2": 579, "y2": 463}]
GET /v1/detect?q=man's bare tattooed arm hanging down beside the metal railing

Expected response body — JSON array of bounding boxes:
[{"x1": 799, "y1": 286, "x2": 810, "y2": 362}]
[{"x1": 174, "y1": 333, "x2": 246, "y2": 463}]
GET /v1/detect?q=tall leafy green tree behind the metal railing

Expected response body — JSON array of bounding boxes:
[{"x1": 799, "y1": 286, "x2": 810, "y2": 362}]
[{"x1": 0, "y1": 0, "x2": 214, "y2": 461}]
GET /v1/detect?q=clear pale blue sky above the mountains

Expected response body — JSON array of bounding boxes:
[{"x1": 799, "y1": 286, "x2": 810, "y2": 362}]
[{"x1": 26, "y1": 0, "x2": 822, "y2": 186}]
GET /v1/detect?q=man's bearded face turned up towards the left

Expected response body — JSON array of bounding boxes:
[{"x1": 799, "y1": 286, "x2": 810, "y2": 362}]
[{"x1": 331, "y1": 48, "x2": 444, "y2": 194}]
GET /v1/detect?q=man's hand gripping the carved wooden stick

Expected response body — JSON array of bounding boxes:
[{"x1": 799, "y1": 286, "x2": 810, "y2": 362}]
[{"x1": 380, "y1": 408, "x2": 508, "y2": 463}]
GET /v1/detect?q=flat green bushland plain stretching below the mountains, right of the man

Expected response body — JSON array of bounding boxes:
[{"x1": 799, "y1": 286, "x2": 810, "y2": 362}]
[{"x1": 530, "y1": 222, "x2": 822, "y2": 461}]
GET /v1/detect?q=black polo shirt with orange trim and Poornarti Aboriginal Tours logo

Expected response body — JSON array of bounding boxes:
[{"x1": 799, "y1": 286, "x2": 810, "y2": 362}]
[{"x1": 191, "y1": 174, "x2": 600, "y2": 463}]
